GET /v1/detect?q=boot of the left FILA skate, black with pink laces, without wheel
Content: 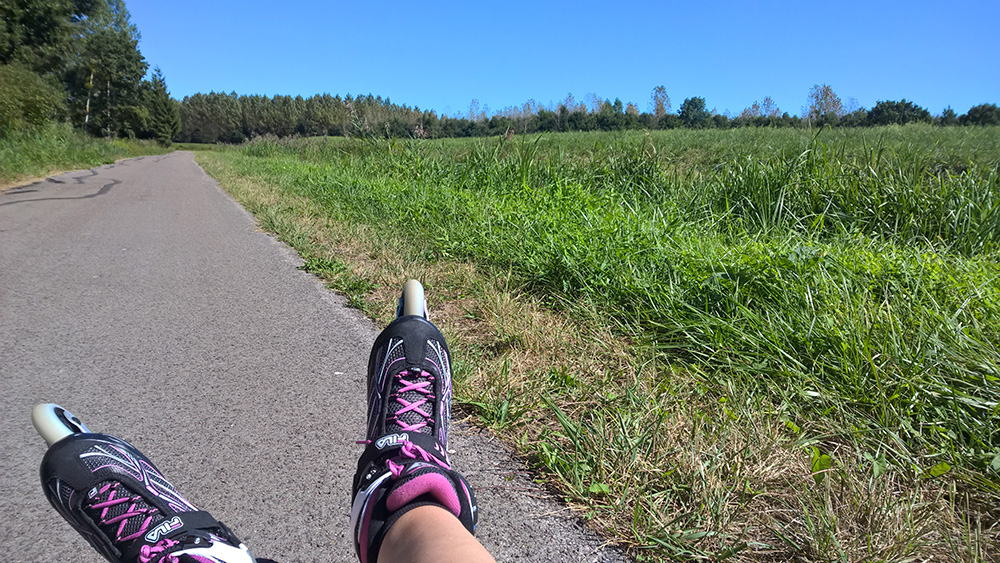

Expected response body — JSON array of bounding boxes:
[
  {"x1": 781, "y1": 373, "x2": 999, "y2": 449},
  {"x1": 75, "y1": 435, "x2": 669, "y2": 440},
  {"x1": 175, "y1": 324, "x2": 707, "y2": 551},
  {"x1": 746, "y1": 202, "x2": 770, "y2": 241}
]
[{"x1": 41, "y1": 433, "x2": 255, "y2": 563}]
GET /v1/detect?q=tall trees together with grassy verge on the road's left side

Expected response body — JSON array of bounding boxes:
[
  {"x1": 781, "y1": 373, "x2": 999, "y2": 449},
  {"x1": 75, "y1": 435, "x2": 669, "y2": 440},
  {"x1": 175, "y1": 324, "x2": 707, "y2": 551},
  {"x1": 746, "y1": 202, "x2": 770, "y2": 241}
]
[{"x1": 0, "y1": 0, "x2": 181, "y2": 188}]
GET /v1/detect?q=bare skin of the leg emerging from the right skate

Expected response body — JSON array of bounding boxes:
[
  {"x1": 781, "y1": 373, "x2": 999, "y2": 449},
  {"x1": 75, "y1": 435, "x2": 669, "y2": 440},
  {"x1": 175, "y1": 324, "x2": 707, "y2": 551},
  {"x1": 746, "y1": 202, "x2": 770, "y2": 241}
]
[{"x1": 378, "y1": 506, "x2": 495, "y2": 563}]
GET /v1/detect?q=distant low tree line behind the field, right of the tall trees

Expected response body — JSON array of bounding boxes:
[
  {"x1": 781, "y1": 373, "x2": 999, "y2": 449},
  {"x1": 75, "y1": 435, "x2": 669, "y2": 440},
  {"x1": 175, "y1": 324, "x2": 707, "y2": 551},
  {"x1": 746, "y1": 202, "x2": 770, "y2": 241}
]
[{"x1": 176, "y1": 85, "x2": 1000, "y2": 143}]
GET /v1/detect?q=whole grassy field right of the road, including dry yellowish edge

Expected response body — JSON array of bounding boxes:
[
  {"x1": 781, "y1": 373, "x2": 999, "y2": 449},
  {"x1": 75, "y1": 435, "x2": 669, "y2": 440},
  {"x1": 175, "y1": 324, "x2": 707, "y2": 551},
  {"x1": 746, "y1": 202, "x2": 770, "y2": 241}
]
[{"x1": 191, "y1": 126, "x2": 1000, "y2": 561}]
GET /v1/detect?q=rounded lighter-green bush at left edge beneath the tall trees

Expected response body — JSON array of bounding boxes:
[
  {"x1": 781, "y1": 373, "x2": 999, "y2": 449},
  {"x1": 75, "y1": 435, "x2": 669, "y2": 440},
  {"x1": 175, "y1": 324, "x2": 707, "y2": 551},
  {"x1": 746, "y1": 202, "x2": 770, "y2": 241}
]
[{"x1": 0, "y1": 63, "x2": 66, "y2": 137}]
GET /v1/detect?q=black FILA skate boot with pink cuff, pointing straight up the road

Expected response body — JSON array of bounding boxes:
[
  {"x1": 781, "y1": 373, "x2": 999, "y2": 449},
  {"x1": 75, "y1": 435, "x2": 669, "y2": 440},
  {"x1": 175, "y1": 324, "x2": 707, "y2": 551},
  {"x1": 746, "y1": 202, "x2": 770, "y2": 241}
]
[{"x1": 351, "y1": 282, "x2": 478, "y2": 563}]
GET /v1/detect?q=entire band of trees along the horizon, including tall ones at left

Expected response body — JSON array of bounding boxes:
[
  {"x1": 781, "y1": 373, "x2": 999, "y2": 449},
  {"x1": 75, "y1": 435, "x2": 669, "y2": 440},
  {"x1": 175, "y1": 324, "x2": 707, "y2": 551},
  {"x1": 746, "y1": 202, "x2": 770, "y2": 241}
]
[{"x1": 0, "y1": 0, "x2": 1000, "y2": 145}]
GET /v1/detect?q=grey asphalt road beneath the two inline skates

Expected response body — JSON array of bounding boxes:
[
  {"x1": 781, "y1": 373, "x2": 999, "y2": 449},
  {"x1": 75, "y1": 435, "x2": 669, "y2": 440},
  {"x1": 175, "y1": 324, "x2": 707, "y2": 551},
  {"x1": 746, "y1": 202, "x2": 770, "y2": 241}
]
[{"x1": 0, "y1": 152, "x2": 624, "y2": 563}]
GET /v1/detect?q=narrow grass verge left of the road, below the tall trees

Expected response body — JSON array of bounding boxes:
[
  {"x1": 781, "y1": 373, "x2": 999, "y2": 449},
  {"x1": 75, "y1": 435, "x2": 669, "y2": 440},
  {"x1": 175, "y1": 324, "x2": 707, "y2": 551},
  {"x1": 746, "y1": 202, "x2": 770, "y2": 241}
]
[{"x1": 0, "y1": 124, "x2": 169, "y2": 188}]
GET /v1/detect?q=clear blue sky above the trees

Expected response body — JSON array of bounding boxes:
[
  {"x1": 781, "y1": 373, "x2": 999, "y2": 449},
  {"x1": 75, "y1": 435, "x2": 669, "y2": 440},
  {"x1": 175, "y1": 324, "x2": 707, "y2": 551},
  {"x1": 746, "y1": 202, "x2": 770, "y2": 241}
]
[{"x1": 126, "y1": 0, "x2": 1000, "y2": 116}]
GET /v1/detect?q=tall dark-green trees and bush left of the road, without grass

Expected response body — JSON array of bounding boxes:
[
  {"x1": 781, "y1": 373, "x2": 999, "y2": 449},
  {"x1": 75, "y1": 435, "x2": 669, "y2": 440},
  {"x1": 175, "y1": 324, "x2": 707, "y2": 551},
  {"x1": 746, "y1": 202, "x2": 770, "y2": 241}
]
[{"x1": 0, "y1": 0, "x2": 181, "y2": 147}]
